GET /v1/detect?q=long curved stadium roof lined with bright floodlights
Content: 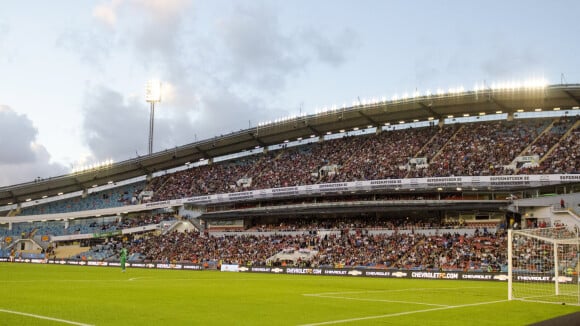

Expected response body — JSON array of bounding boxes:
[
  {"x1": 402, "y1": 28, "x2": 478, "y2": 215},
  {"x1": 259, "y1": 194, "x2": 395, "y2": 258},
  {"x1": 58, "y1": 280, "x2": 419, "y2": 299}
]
[{"x1": 0, "y1": 84, "x2": 580, "y2": 206}]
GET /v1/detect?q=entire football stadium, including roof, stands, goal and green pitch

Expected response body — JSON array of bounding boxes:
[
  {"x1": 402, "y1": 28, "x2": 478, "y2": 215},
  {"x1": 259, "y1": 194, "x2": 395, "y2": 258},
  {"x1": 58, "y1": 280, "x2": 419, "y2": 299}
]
[{"x1": 0, "y1": 82, "x2": 580, "y2": 325}]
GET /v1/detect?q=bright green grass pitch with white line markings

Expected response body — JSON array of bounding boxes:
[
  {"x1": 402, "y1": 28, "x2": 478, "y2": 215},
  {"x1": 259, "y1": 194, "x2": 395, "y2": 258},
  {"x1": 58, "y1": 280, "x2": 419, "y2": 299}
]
[{"x1": 0, "y1": 263, "x2": 580, "y2": 326}]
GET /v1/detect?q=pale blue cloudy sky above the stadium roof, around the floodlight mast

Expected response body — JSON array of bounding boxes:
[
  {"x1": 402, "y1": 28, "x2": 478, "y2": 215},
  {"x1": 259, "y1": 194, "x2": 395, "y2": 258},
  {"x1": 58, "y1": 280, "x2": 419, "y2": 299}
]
[{"x1": 0, "y1": 0, "x2": 580, "y2": 187}]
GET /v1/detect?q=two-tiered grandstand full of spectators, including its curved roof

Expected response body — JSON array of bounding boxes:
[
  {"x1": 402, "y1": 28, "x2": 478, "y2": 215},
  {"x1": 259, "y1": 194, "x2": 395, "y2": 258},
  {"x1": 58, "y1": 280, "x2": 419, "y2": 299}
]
[{"x1": 0, "y1": 84, "x2": 580, "y2": 272}]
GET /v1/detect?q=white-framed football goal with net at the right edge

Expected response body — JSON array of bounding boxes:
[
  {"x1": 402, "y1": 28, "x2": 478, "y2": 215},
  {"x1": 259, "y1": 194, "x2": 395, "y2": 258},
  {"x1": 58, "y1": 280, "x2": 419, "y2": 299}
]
[{"x1": 508, "y1": 226, "x2": 580, "y2": 305}]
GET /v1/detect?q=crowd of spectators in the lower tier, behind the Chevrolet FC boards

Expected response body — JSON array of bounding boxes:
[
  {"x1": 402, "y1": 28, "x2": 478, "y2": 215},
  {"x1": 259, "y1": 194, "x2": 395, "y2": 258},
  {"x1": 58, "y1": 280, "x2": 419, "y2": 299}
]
[{"x1": 123, "y1": 225, "x2": 507, "y2": 271}]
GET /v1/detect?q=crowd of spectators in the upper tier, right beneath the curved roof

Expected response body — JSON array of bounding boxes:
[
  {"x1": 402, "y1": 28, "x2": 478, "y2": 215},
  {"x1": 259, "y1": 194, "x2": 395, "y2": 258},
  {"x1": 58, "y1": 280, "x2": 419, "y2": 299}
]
[{"x1": 148, "y1": 118, "x2": 580, "y2": 200}]
